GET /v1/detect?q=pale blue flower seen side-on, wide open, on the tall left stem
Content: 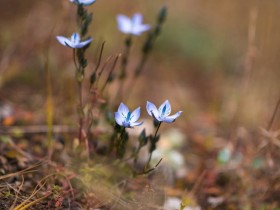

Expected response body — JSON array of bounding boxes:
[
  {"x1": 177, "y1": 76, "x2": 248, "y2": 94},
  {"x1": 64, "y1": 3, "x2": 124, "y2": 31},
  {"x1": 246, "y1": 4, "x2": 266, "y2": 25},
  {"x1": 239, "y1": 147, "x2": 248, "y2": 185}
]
[{"x1": 56, "y1": 33, "x2": 93, "y2": 48}]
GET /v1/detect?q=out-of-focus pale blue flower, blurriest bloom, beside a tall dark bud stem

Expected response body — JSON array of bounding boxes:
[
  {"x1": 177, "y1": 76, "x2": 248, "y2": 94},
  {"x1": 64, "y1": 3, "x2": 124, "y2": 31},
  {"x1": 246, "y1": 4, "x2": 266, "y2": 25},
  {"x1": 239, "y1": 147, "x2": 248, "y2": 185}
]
[{"x1": 117, "y1": 13, "x2": 151, "y2": 36}]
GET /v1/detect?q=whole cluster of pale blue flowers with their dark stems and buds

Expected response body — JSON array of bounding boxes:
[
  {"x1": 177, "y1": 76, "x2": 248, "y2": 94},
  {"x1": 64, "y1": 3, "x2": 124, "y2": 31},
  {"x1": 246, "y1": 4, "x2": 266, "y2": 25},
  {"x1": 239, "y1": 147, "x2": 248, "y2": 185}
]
[{"x1": 56, "y1": 0, "x2": 182, "y2": 173}]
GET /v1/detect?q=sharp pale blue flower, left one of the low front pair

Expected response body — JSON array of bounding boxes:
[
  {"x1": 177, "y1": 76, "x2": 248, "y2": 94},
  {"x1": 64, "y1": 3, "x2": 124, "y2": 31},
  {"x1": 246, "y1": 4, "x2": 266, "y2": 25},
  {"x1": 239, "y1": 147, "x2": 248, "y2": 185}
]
[{"x1": 115, "y1": 103, "x2": 143, "y2": 128}]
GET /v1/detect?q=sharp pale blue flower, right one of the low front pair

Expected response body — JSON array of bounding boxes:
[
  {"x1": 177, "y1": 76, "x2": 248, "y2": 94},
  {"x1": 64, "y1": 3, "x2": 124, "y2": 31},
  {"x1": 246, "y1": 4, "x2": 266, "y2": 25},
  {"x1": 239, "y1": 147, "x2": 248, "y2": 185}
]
[{"x1": 146, "y1": 100, "x2": 182, "y2": 123}]
